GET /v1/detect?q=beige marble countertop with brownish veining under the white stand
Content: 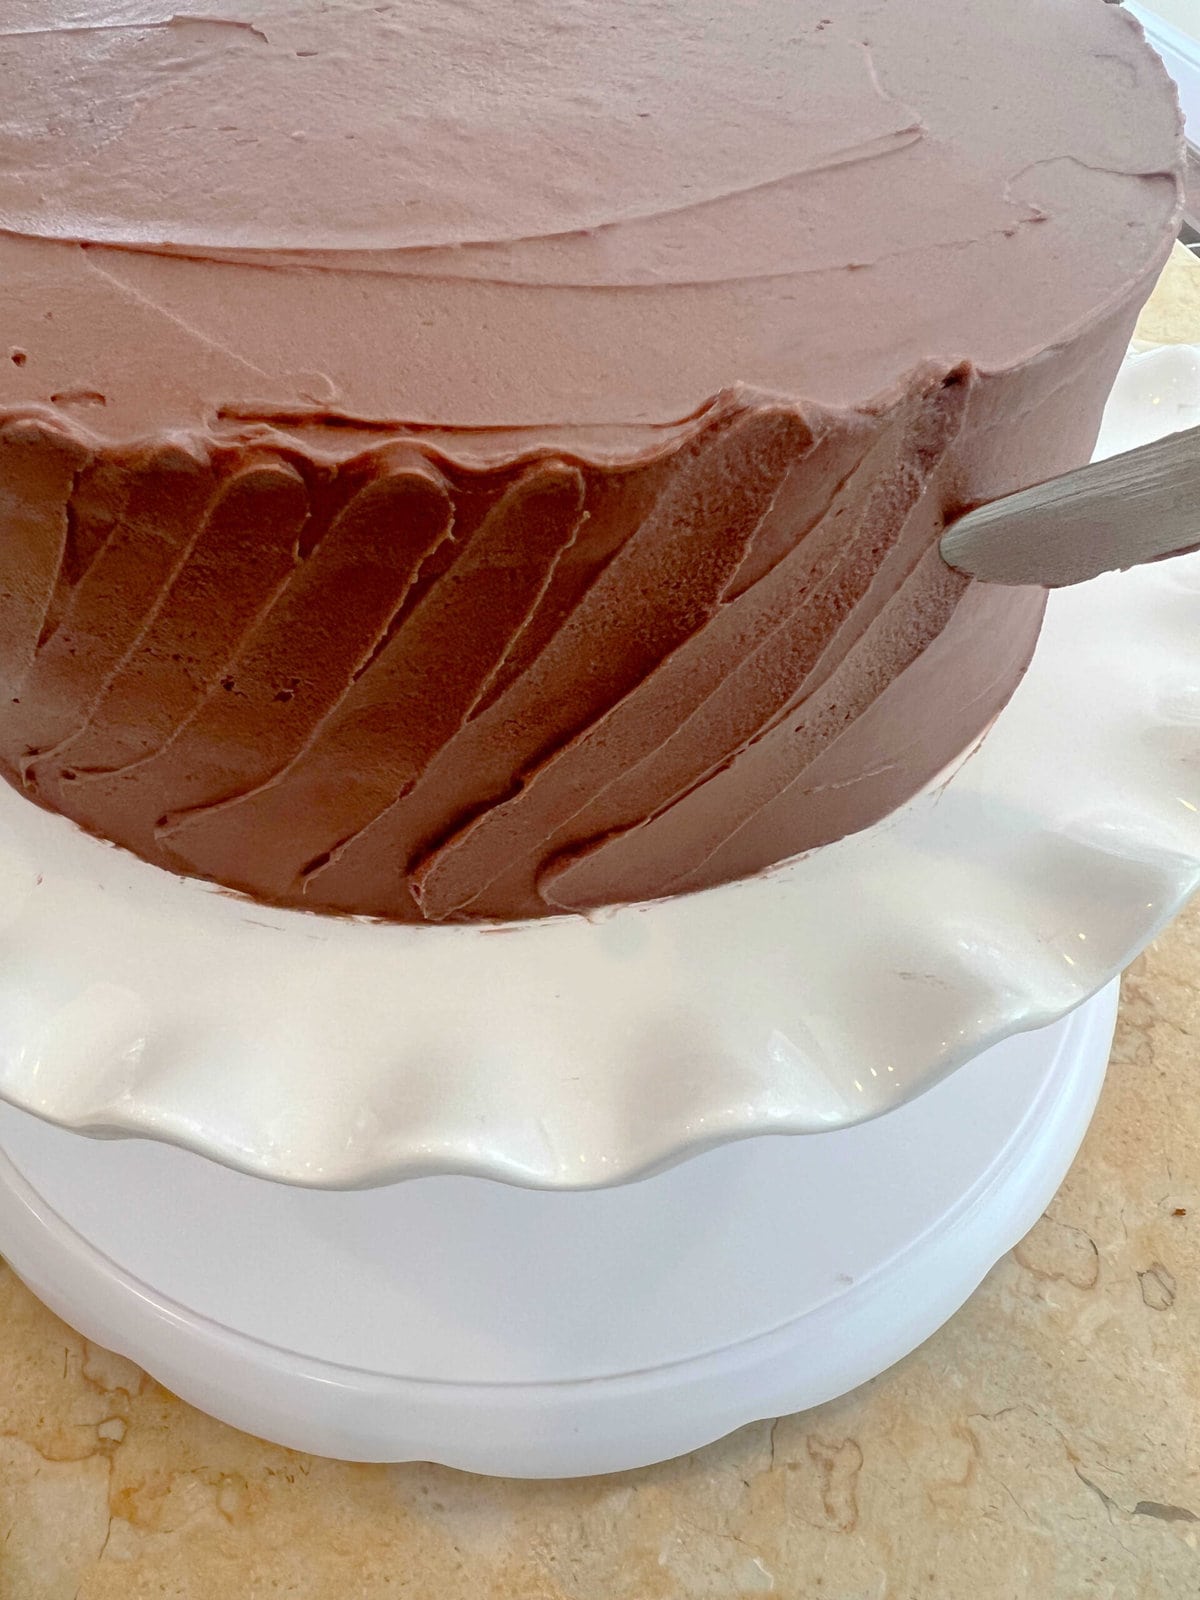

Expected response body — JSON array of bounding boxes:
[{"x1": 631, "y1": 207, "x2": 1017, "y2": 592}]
[{"x1": 0, "y1": 251, "x2": 1200, "y2": 1600}]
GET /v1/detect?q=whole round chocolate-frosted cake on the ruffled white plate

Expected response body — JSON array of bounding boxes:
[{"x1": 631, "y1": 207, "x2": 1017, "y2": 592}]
[{"x1": 0, "y1": 0, "x2": 1181, "y2": 922}]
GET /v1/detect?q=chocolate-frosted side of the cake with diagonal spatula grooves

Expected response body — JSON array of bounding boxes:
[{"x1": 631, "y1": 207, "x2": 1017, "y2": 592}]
[{"x1": 0, "y1": 300, "x2": 1133, "y2": 920}]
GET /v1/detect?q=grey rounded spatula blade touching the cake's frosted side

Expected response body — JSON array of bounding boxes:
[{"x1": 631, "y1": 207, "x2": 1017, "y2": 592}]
[{"x1": 941, "y1": 427, "x2": 1200, "y2": 589}]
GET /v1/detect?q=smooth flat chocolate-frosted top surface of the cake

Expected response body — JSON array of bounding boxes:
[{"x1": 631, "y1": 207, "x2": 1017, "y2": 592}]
[{"x1": 0, "y1": 0, "x2": 1181, "y2": 451}]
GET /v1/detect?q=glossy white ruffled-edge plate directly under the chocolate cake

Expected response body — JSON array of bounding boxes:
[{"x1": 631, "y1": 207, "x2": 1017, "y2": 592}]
[{"x1": 0, "y1": 347, "x2": 1200, "y2": 1203}]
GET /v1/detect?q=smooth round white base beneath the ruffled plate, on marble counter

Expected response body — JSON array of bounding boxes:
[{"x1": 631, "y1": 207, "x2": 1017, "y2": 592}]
[{"x1": 0, "y1": 984, "x2": 1117, "y2": 1477}]
